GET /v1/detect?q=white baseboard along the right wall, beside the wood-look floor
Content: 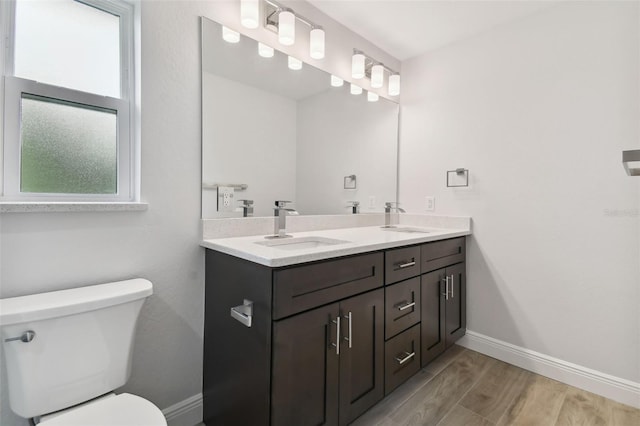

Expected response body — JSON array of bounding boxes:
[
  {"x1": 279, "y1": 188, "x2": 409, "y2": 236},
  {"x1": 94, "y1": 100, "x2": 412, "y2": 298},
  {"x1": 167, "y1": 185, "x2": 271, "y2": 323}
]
[{"x1": 457, "y1": 331, "x2": 640, "y2": 408}]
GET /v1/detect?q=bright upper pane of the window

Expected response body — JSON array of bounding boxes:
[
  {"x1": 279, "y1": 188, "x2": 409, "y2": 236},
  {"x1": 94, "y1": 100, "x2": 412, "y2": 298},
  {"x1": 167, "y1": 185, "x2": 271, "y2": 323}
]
[{"x1": 14, "y1": 0, "x2": 120, "y2": 98}]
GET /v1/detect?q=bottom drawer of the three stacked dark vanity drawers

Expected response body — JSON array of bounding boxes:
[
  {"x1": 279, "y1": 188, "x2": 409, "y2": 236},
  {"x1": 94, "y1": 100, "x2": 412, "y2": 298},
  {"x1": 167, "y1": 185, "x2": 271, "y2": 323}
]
[{"x1": 384, "y1": 324, "x2": 420, "y2": 395}]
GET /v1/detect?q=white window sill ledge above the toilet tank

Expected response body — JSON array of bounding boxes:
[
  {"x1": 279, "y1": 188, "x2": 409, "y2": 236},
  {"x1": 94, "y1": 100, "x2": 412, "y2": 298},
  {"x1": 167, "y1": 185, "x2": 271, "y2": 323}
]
[{"x1": 0, "y1": 201, "x2": 149, "y2": 213}]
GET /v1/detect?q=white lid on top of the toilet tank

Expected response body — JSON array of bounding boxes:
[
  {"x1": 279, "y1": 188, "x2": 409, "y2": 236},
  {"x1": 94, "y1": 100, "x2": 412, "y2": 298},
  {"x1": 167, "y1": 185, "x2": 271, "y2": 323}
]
[{"x1": 0, "y1": 278, "x2": 153, "y2": 325}]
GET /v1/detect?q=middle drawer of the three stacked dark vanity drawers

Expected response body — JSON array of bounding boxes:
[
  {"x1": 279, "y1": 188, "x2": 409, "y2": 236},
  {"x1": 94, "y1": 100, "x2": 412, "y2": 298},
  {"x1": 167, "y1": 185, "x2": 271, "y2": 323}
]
[{"x1": 384, "y1": 277, "x2": 421, "y2": 339}]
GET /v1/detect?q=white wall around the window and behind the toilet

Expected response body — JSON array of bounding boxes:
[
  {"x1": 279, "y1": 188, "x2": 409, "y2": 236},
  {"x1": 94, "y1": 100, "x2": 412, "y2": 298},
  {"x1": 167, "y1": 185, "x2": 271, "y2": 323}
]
[{"x1": 0, "y1": 0, "x2": 397, "y2": 426}]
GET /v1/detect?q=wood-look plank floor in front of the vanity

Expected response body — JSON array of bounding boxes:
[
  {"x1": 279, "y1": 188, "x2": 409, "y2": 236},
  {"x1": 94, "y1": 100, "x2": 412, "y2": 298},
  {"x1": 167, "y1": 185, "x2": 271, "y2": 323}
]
[{"x1": 353, "y1": 345, "x2": 640, "y2": 426}]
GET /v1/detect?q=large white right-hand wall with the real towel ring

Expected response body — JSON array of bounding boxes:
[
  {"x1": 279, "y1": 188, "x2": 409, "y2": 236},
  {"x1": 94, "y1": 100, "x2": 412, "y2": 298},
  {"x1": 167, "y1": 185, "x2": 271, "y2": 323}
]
[{"x1": 400, "y1": 2, "x2": 640, "y2": 383}]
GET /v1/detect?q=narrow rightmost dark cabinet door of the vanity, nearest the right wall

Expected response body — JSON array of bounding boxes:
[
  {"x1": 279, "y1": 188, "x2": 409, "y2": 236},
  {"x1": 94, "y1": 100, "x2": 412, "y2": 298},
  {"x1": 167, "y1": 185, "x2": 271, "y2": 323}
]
[{"x1": 445, "y1": 263, "x2": 467, "y2": 347}]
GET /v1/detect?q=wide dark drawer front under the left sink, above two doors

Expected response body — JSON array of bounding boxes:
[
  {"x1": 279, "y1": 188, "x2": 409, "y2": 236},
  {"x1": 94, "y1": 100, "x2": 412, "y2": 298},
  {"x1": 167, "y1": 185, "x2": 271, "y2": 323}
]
[{"x1": 273, "y1": 253, "x2": 384, "y2": 319}]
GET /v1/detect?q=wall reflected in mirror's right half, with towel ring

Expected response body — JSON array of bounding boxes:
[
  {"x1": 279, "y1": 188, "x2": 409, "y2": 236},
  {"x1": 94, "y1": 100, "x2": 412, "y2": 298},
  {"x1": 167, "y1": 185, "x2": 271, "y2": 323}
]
[{"x1": 295, "y1": 85, "x2": 398, "y2": 214}]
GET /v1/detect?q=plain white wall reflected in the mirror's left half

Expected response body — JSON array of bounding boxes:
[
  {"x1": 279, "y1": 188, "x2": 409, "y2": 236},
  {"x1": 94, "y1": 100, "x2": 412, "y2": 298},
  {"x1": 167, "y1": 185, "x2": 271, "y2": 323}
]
[{"x1": 202, "y1": 72, "x2": 296, "y2": 218}]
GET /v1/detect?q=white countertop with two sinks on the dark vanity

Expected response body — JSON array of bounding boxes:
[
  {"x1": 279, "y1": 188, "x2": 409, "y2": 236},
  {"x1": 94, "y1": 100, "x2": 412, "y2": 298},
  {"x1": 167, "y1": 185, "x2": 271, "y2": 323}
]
[{"x1": 200, "y1": 225, "x2": 471, "y2": 267}]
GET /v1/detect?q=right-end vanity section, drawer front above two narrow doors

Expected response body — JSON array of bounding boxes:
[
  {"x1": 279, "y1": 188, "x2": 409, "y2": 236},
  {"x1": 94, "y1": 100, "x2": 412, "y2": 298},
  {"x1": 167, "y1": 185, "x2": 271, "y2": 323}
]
[{"x1": 420, "y1": 238, "x2": 467, "y2": 366}]
